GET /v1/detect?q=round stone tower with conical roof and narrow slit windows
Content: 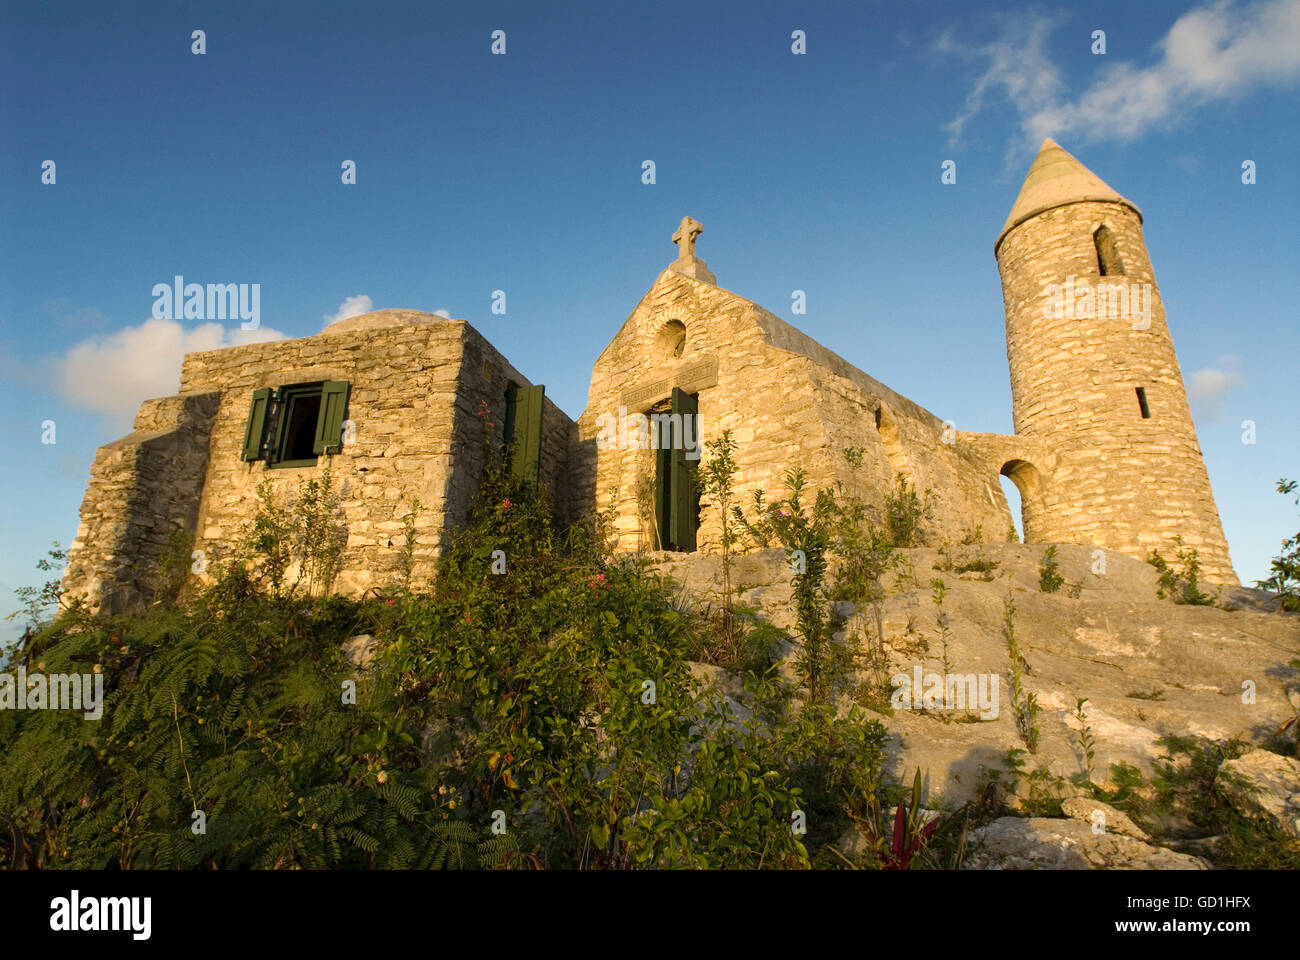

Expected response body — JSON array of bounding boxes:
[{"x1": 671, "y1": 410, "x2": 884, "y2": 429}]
[{"x1": 993, "y1": 139, "x2": 1236, "y2": 584}]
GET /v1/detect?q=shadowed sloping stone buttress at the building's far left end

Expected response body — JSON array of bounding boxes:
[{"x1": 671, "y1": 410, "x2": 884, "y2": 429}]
[{"x1": 64, "y1": 392, "x2": 220, "y2": 614}]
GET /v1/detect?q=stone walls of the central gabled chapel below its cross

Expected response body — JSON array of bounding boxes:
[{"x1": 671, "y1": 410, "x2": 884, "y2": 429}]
[{"x1": 571, "y1": 271, "x2": 1011, "y2": 552}]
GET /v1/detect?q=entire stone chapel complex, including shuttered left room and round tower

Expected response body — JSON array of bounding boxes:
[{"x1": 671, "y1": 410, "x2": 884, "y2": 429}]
[{"x1": 64, "y1": 139, "x2": 1236, "y2": 611}]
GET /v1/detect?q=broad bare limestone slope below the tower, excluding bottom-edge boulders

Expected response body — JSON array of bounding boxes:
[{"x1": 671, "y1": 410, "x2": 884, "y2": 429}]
[{"x1": 655, "y1": 542, "x2": 1300, "y2": 809}]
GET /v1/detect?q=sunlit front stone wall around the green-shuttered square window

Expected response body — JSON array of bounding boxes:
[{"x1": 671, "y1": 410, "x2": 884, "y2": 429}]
[{"x1": 181, "y1": 321, "x2": 463, "y2": 592}]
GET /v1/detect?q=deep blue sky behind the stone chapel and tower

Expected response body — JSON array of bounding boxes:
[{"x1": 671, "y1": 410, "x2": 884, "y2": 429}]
[{"x1": 0, "y1": 0, "x2": 1300, "y2": 632}]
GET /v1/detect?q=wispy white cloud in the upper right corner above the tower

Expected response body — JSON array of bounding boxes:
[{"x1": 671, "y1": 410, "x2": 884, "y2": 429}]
[{"x1": 936, "y1": 0, "x2": 1300, "y2": 150}]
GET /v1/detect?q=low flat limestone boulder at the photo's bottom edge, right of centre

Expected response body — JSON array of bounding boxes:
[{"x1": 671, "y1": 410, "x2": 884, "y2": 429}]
[{"x1": 963, "y1": 817, "x2": 1210, "y2": 870}]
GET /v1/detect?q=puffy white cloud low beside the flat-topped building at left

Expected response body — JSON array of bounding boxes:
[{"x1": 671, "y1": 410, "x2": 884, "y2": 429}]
[{"x1": 55, "y1": 319, "x2": 285, "y2": 431}]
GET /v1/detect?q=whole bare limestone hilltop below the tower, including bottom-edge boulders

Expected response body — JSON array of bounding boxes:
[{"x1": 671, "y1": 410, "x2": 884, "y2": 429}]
[{"x1": 659, "y1": 542, "x2": 1300, "y2": 868}]
